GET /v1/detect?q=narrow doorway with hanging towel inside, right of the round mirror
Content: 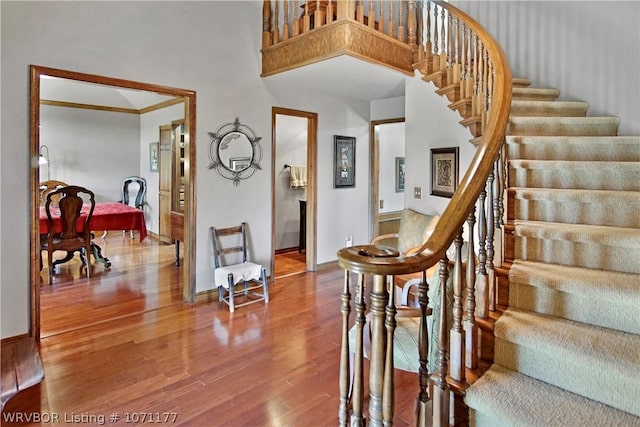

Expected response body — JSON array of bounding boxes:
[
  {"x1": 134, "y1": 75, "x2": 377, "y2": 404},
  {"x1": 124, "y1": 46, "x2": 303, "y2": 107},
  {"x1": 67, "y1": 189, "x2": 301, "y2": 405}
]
[{"x1": 271, "y1": 107, "x2": 318, "y2": 278}]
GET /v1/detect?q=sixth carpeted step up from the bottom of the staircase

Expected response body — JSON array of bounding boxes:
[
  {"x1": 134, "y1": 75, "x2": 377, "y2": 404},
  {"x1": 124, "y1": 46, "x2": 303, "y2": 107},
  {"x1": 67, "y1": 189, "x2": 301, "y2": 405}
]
[{"x1": 509, "y1": 160, "x2": 640, "y2": 191}]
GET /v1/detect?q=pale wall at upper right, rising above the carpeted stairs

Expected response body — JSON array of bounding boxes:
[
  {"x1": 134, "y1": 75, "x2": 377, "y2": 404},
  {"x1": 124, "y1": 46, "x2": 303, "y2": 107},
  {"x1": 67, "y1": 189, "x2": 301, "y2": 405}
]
[{"x1": 452, "y1": 1, "x2": 640, "y2": 135}]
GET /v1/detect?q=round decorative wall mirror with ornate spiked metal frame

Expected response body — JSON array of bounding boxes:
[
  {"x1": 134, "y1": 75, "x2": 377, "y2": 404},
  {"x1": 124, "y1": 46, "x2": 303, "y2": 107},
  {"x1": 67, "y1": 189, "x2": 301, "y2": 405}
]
[{"x1": 208, "y1": 117, "x2": 262, "y2": 185}]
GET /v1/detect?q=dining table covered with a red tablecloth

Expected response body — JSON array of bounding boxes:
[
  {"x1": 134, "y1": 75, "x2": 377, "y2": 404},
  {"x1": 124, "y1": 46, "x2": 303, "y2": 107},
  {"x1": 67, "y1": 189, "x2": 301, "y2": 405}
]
[{"x1": 40, "y1": 202, "x2": 147, "y2": 268}]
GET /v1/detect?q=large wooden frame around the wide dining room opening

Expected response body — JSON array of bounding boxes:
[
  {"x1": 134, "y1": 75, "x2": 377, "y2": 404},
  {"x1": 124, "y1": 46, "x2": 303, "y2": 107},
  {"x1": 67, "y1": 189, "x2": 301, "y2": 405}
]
[{"x1": 29, "y1": 65, "x2": 196, "y2": 340}]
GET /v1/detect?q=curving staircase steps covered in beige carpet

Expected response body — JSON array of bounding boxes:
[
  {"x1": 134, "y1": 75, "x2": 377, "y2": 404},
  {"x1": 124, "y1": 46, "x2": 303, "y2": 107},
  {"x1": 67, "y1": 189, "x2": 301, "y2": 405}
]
[{"x1": 465, "y1": 79, "x2": 640, "y2": 427}]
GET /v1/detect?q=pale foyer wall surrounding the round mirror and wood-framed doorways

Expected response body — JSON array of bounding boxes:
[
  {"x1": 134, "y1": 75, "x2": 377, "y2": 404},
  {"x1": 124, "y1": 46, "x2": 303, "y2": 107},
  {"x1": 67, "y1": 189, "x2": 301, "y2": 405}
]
[{"x1": 0, "y1": 1, "x2": 370, "y2": 337}]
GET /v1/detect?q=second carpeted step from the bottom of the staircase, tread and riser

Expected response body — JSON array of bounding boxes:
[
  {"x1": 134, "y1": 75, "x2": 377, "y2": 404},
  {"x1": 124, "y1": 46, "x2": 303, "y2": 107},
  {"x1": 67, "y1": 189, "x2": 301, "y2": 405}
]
[{"x1": 494, "y1": 308, "x2": 640, "y2": 416}]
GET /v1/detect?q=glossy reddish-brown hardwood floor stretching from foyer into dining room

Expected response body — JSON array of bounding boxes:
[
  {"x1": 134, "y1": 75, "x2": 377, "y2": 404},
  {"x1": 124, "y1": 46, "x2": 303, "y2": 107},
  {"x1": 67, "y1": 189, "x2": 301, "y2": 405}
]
[{"x1": 7, "y1": 240, "x2": 418, "y2": 426}]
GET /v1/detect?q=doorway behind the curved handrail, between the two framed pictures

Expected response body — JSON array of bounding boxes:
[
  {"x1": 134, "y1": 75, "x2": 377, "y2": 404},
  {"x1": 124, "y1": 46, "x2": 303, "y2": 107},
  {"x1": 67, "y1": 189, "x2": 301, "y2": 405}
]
[{"x1": 369, "y1": 118, "x2": 406, "y2": 238}]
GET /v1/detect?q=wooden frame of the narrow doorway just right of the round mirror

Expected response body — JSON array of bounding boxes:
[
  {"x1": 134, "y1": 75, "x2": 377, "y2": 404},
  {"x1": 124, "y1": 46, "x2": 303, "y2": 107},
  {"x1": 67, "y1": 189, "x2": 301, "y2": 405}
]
[{"x1": 271, "y1": 107, "x2": 318, "y2": 277}]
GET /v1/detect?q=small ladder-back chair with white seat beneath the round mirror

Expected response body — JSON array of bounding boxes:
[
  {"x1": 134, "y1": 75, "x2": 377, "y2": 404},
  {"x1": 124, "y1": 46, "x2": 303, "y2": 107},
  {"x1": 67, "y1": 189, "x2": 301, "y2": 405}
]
[{"x1": 210, "y1": 222, "x2": 269, "y2": 313}]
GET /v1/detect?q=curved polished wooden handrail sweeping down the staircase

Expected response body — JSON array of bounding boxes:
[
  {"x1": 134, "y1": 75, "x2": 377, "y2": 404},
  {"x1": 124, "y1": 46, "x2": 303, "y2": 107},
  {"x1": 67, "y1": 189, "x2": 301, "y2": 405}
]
[{"x1": 338, "y1": 0, "x2": 512, "y2": 275}]
